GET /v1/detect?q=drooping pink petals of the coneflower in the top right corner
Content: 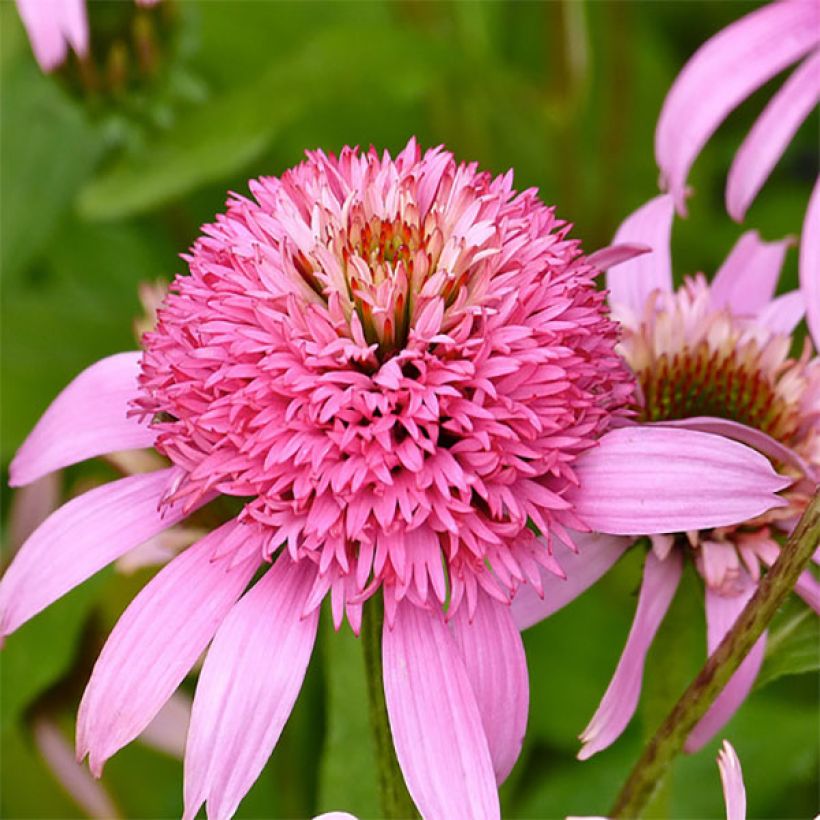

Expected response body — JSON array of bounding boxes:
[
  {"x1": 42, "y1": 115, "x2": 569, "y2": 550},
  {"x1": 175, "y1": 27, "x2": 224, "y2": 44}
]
[{"x1": 655, "y1": 0, "x2": 820, "y2": 338}]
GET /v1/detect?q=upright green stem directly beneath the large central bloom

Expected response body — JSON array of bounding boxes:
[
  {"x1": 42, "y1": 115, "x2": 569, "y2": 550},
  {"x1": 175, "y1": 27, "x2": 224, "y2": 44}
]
[{"x1": 362, "y1": 596, "x2": 418, "y2": 820}]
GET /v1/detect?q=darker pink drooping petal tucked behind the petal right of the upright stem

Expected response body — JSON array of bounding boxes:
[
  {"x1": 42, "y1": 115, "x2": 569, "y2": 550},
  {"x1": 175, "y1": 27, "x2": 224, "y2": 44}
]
[{"x1": 450, "y1": 591, "x2": 530, "y2": 785}]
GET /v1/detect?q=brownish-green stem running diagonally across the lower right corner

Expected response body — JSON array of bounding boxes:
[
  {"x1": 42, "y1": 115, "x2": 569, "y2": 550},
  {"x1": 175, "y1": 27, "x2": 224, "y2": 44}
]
[{"x1": 609, "y1": 493, "x2": 820, "y2": 818}]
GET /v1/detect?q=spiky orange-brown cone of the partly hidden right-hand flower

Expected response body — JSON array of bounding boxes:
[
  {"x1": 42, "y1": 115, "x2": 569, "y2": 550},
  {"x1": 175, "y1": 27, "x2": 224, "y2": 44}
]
[{"x1": 635, "y1": 341, "x2": 799, "y2": 442}]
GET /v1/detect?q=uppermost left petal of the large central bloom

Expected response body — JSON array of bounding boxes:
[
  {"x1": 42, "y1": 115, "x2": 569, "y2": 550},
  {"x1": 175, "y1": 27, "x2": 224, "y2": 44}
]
[{"x1": 9, "y1": 353, "x2": 156, "y2": 487}]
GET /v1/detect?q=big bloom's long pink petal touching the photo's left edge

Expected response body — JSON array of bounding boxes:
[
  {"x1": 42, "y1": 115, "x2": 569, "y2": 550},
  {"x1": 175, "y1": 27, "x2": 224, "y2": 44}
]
[{"x1": 0, "y1": 467, "x2": 190, "y2": 635}]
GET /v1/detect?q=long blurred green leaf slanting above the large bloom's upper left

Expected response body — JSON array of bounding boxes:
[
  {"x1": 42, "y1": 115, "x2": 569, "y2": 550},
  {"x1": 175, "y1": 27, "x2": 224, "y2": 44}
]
[{"x1": 80, "y1": 27, "x2": 446, "y2": 219}]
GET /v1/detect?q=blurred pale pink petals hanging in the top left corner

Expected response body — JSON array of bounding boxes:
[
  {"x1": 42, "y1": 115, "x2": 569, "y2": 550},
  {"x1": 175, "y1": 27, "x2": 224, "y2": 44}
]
[{"x1": 16, "y1": 0, "x2": 158, "y2": 73}]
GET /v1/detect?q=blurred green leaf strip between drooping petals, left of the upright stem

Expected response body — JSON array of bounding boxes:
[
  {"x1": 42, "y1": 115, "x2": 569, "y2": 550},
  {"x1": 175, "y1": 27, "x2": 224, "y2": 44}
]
[{"x1": 319, "y1": 613, "x2": 380, "y2": 817}]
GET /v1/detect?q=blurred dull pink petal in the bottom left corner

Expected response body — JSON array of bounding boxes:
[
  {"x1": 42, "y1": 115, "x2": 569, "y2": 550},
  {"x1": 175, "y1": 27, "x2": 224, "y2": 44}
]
[{"x1": 32, "y1": 718, "x2": 122, "y2": 820}]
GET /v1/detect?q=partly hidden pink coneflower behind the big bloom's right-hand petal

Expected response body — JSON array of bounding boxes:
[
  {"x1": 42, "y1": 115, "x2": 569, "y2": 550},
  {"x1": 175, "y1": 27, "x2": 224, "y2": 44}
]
[{"x1": 513, "y1": 195, "x2": 820, "y2": 759}]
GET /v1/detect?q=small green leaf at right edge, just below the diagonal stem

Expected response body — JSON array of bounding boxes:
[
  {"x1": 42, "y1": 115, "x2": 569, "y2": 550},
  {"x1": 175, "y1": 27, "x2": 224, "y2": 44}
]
[{"x1": 755, "y1": 599, "x2": 820, "y2": 688}]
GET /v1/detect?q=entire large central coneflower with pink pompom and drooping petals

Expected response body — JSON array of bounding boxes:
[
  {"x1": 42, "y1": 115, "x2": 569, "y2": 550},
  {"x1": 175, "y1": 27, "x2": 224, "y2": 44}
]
[{"x1": 0, "y1": 140, "x2": 784, "y2": 818}]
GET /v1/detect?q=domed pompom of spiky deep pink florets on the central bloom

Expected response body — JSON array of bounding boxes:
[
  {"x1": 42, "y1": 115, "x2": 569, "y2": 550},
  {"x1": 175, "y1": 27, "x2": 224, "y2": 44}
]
[{"x1": 135, "y1": 141, "x2": 631, "y2": 627}]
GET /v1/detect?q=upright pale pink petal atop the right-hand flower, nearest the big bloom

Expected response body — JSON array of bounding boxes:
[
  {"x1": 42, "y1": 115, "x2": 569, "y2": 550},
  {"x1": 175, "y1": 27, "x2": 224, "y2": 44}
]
[{"x1": 606, "y1": 195, "x2": 674, "y2": 314}]
